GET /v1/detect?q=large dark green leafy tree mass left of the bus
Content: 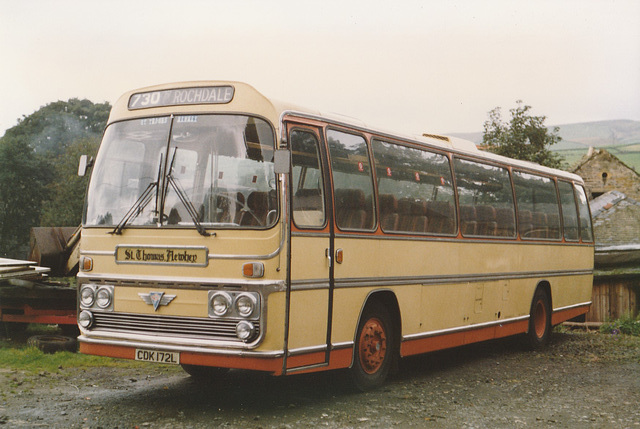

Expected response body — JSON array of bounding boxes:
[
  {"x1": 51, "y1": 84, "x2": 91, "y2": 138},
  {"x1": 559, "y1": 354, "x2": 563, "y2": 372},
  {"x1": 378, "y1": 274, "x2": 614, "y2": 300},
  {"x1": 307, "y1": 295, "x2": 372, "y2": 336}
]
[{"x1": 0, "y1": 98, "x2": 111, "y2": 258}]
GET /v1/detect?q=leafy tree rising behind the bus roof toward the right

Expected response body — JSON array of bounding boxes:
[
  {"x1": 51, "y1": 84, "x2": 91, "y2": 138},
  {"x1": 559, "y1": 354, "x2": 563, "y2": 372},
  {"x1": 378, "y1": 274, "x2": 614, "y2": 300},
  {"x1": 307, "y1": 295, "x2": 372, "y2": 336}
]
[{"x1": 481, "y1": 100, "x2": 562, "y2": 168}]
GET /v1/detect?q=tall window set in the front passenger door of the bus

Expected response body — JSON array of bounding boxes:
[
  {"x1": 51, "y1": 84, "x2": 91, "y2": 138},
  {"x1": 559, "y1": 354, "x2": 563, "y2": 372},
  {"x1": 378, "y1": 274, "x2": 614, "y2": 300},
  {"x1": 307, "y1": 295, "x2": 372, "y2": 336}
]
[{"x1": 291, "y1": 130, "x2": 326, "y2": 228}]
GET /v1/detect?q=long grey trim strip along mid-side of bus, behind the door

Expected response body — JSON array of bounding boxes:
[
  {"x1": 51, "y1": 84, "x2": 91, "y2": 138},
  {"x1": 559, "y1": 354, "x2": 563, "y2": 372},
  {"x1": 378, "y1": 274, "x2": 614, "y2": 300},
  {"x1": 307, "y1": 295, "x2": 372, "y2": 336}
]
[{"x1": 335, "y1": 270, "x2": 593, "y2": 288}]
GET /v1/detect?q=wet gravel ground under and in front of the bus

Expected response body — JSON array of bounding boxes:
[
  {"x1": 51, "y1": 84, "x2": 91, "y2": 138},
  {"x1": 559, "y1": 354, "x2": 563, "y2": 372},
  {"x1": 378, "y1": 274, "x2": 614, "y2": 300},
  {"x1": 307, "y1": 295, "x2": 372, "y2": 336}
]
[{"x1": 0, "y1": 332, "x2": 640, "y2": 428}]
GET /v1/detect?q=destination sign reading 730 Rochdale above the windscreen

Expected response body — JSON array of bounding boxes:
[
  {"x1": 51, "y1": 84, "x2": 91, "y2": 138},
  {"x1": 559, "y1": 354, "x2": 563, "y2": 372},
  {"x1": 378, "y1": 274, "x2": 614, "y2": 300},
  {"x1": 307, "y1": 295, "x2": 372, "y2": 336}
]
[{"x1": 129, "y1": 85, "x2": 235, "y2": 110}]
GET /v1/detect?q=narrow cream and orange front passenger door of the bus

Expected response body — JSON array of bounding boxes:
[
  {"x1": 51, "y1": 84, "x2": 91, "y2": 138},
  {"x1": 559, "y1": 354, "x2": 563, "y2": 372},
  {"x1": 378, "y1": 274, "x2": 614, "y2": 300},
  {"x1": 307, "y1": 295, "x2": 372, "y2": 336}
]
[{"x1": 285, "y1": 122, "x2": 334, "y2": 372}]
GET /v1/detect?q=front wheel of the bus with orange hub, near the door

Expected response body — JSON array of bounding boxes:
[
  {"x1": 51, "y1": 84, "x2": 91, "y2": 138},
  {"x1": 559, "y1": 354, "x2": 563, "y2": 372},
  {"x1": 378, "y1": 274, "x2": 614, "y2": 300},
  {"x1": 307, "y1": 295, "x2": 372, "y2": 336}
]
[{"x1": 351, "y1": 301, "x2": 395, "y2": 391}]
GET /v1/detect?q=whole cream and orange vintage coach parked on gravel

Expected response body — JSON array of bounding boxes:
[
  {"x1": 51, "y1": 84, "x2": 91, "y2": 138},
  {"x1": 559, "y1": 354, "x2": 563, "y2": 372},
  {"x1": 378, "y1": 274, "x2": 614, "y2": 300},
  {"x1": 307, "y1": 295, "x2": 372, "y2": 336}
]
[{"x1": 78, "y1": 81, "x2": 594, "y2": 390}]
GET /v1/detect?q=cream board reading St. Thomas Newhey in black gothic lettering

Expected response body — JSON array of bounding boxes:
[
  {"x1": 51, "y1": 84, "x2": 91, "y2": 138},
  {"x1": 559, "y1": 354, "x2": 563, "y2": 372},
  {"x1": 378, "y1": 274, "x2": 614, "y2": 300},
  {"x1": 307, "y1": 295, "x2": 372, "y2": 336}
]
[{"x1": 116, "y1": 246, "x2": 209, "y2": 267}]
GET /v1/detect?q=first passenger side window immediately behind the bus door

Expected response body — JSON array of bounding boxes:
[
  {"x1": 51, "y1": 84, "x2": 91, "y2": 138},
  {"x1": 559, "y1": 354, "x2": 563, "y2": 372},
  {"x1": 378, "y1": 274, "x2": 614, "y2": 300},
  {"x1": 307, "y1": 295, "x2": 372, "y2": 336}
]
[{"x1": 327, "y1": 129, "x2": 376, "y2": 231}]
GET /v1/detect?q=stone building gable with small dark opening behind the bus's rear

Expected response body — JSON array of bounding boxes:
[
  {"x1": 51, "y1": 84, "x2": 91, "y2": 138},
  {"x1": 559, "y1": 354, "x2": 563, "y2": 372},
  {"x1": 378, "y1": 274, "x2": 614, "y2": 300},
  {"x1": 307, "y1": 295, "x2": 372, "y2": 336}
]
[{"x1": 572, "y1": 148, "x2": 640, "y2": 201}]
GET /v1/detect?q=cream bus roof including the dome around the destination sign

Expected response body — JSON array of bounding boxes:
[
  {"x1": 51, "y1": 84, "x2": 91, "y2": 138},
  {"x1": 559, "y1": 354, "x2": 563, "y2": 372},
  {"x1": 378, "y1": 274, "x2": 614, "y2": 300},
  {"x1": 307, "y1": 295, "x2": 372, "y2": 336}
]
[{"x1": 108, "y1": 81, "x2": 583, "y2": 182}]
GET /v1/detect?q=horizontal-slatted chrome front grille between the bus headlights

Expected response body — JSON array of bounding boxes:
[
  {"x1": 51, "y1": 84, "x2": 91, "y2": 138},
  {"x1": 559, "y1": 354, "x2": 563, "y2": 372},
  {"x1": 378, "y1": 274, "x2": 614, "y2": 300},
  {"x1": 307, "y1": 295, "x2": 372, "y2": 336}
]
[{"x1": 92, "y1": 312, "x2": 259, "y2": 342}]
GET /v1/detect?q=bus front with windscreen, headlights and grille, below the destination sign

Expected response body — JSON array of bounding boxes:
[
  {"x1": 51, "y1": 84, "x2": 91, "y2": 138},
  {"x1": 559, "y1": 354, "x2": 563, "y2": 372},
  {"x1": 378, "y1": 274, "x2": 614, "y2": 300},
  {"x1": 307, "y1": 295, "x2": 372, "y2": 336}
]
[{"x1": 78, "y1": 87, "x2": 286, "y2": 372}]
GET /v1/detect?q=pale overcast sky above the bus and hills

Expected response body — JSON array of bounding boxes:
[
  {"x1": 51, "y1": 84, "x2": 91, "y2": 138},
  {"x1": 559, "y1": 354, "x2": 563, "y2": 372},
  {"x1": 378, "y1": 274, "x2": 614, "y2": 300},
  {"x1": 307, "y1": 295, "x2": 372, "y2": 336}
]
[{"x1": 0, "y1": 0, "x2": 640, "y2": 136}]
